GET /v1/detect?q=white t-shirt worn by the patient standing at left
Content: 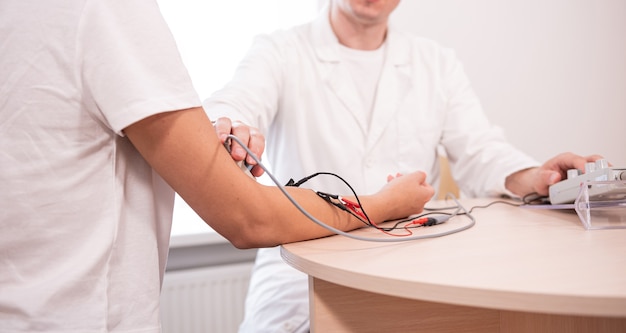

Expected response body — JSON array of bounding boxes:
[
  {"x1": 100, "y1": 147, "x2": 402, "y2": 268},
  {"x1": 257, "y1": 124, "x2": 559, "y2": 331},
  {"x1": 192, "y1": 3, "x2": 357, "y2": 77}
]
[{"x1": 0, "y1": 0, "x2": 200, "y2": 333}]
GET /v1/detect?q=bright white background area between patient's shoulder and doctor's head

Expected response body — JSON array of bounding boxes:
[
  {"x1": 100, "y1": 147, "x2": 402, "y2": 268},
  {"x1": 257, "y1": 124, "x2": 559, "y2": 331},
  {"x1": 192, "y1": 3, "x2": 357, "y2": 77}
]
[{"x1": 157, "y1": 0, "x2": 318, "y2": 99}]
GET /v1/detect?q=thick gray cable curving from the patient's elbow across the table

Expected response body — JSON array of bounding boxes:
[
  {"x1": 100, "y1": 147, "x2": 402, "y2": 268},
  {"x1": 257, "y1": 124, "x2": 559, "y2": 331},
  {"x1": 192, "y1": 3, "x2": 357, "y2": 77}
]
[{"x1": 228, "y1": 134, "x2": 476, "y2": 243}]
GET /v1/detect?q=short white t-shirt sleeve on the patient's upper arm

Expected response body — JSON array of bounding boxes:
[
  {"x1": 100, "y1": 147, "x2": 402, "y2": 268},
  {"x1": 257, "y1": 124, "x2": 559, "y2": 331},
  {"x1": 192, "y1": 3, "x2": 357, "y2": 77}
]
[{"x1": 77, "y1": 0, "x2": 201, "y2": 135}]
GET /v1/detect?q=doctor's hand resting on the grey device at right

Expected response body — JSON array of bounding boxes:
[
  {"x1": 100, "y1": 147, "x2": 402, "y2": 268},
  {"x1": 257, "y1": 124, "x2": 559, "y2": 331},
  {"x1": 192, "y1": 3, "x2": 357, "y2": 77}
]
[{"x1": 505, "y1": 153, "x2": 602, "y2": 197}]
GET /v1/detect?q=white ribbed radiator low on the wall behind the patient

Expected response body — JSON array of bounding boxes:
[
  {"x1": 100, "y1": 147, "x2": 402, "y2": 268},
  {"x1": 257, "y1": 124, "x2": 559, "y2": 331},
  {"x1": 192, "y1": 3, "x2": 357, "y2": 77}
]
[{"x1": 161, "y1": 263, "x2": 253, "y2": 333}]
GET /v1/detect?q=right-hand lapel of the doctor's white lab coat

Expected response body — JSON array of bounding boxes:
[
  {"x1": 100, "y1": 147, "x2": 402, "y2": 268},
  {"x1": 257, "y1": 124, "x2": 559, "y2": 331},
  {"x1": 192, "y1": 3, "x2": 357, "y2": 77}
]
[{"x1": 367, "y1": 27, "x2": 412, "y2": 150}]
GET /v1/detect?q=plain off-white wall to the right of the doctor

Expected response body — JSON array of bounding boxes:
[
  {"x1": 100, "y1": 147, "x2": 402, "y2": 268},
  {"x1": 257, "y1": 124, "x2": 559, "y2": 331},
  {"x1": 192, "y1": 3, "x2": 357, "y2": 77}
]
[{"x1": 392, "y1": 0, "x2": 626, "y2": 167}]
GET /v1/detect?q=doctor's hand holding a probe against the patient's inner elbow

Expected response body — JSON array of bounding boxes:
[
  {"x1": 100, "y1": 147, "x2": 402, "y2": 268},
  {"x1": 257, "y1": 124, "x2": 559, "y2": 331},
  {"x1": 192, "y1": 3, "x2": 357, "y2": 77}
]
[{"x1": 213, "y1": 117, "x2": 265, "y2": 177}]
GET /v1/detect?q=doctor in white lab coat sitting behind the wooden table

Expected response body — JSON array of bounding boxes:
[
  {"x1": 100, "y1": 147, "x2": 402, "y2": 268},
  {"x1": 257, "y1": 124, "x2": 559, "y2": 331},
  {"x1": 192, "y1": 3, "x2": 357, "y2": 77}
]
[{"x1": 204, "y1": 0, "x2": 598, "y2": 332}]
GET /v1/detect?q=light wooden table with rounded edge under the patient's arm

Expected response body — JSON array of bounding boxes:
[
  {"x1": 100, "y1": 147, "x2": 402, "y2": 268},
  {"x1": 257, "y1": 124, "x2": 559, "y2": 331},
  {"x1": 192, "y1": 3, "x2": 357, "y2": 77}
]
[{"x1": 281, "y1": 199, "x2": 626, "y2": 333}]
